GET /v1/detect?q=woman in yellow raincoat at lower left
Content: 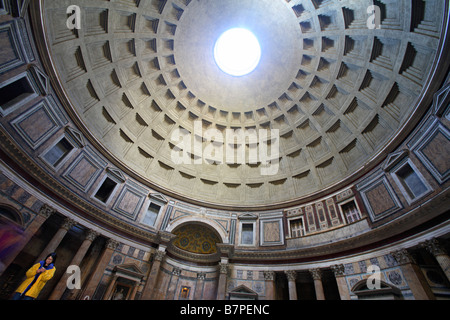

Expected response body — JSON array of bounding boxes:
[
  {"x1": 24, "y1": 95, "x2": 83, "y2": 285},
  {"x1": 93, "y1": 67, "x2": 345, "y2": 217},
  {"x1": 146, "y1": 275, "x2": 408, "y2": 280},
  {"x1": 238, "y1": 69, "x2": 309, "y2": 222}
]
[{"x1": 12, "y1": 253, "x2": 56, "y2": 300}]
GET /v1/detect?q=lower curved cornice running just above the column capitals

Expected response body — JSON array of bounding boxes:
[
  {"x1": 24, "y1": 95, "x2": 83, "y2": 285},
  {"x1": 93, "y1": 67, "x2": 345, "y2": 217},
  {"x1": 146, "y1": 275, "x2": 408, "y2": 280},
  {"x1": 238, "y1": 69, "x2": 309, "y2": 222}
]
[{"x1": 0, "y1": 121, "x2": 450, "y2": 263}]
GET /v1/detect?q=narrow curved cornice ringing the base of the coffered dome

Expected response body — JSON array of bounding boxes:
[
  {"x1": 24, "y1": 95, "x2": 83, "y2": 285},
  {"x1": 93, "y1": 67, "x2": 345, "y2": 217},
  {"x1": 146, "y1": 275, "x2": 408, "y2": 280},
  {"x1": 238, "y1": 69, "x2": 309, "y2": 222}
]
[{"x1": 30, "y1": 0, "x2": 450, "y2": 212}]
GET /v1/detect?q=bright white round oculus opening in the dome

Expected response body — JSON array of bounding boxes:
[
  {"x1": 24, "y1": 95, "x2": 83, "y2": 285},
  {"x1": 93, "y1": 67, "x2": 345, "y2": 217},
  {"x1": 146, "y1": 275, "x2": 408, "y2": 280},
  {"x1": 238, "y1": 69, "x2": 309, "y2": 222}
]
[{"x1": 214, "y1": 28, "x2": 261, "y2": 77}]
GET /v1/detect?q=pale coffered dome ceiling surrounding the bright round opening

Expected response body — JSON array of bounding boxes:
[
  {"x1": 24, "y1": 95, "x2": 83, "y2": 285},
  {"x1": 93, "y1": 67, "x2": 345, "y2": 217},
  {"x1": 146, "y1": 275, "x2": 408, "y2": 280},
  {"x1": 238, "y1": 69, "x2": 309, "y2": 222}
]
[{"x1": 39, "y1": 0, "x2": 446, "y2": 208}]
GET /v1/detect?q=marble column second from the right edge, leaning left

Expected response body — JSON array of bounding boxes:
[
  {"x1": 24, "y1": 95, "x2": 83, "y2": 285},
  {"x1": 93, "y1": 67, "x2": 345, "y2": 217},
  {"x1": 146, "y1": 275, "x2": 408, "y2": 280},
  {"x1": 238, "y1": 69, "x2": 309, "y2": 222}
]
[{"x1": 391, "y1": 249, "x2": 436, "y2": 300}]
